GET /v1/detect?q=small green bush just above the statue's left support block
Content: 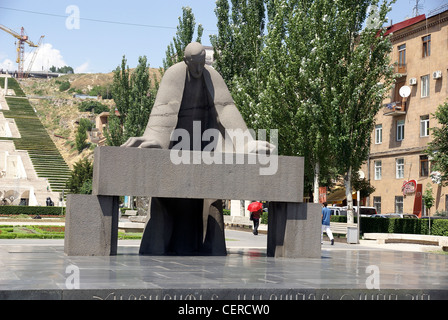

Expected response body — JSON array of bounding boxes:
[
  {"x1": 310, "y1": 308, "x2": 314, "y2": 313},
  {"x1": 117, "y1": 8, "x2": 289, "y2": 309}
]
[{"x1": 66, "y1": 159, "x2": 93, "y2": 194}]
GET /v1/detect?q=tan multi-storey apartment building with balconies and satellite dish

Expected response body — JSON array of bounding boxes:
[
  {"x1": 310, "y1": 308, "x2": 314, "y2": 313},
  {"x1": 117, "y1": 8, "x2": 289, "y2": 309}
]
[{"x1": 362, "y1": 8, "x2": 448, "y2": 216}]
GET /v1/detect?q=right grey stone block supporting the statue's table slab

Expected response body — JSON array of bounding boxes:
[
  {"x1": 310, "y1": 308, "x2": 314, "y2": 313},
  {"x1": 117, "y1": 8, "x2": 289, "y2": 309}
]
[{"x1": 267, "y1": 202, "x2": 322, "y2": 258}]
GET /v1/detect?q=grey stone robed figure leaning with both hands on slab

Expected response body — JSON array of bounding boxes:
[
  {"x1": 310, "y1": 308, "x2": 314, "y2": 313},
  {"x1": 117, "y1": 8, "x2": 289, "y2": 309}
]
[{"x1": 122, "y1": 42, "x2": 274, "y2": 255}]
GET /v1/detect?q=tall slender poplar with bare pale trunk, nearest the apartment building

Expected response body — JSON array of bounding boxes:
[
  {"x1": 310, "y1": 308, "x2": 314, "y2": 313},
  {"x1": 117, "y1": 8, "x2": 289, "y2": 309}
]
[{"x1": 332, "y1": 0, "x2": 393, "y2": 222}]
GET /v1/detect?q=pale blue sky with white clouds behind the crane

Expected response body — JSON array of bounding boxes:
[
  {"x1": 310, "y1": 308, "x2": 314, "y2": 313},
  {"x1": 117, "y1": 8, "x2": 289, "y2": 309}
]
[{"x1": 0, "y1": 0, "x2": 448, "y2": 73}]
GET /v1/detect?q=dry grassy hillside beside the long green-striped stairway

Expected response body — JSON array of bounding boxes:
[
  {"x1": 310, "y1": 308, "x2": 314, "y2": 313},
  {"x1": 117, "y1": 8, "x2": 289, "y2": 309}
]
[{"x1": 20, "y1": 69, "x2": 160, "y2": 168}]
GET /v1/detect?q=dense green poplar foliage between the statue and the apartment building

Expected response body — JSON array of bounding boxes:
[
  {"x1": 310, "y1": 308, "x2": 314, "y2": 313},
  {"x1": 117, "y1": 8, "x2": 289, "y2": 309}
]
[{"x1": 211, "y1": 0, "x2": 392, "y2": 218}]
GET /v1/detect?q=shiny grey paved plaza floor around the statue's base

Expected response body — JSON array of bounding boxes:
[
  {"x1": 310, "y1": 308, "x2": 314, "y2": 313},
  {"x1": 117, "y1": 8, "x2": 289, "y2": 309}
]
[{"x1": 0, "y1": 230, "x2": 448, "y2": 300}]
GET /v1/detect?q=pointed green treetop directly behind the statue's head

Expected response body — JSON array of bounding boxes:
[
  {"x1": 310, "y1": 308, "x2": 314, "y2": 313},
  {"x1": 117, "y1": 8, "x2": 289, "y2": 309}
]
[{"x1": 163, "y1": 7, "x2": 204, "y2": 70}]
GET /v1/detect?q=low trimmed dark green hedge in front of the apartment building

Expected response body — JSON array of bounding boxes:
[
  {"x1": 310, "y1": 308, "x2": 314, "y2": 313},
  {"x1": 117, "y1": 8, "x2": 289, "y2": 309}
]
[{"x1": 331, "y1": 216, "x2": 448, "y2": 236}]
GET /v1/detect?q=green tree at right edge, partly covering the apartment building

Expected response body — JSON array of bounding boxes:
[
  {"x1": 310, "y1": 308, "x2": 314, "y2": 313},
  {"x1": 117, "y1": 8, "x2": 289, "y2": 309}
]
[{"x1": 426, "y1": 102, "x2": 448, "y2": 185}]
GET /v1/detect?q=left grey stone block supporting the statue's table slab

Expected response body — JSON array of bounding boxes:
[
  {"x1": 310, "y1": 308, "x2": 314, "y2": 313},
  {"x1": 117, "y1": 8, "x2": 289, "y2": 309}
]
[{"x1": 64, "y1": 194, "x2": 118, "y2": 256}]
